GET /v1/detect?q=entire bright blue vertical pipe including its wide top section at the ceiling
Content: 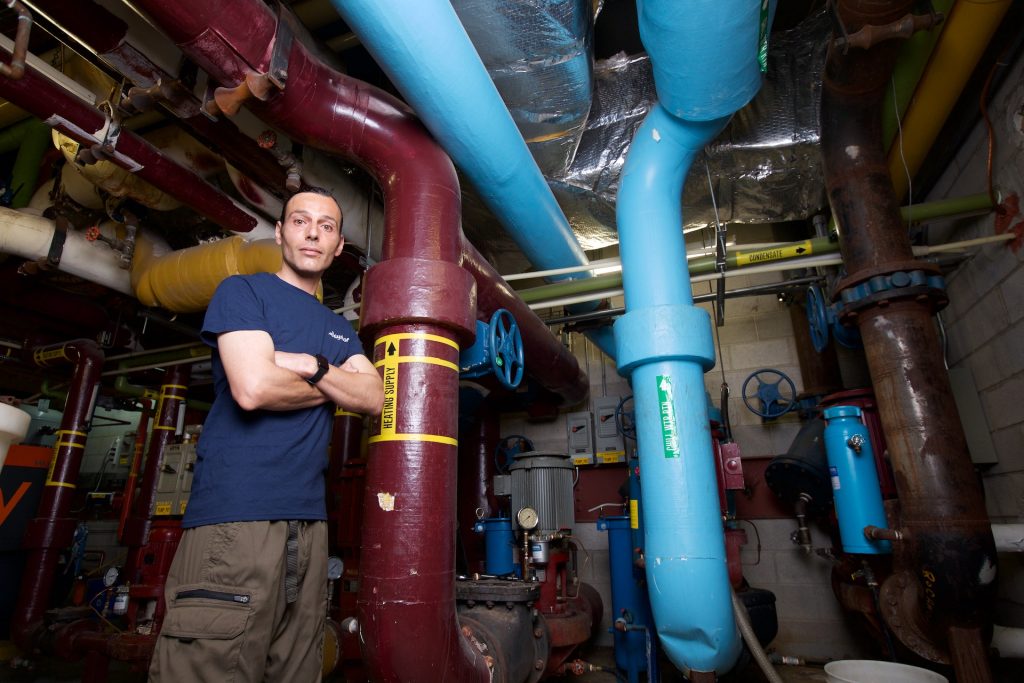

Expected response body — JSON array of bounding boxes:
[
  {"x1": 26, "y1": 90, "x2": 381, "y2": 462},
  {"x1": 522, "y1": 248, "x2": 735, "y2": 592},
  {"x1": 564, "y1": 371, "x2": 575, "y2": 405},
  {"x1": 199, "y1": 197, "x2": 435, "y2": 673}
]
[{"x1": 614, "y1": 0, "x2": 774, "y2": 680}]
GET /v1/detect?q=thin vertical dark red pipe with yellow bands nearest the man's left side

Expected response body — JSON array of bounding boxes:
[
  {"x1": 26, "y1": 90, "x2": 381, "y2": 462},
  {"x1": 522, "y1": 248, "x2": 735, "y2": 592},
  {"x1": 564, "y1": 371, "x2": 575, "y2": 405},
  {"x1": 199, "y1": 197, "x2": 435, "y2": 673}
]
[{"x1": 123, "y1": 365, "x2": 191, "y2": 583}]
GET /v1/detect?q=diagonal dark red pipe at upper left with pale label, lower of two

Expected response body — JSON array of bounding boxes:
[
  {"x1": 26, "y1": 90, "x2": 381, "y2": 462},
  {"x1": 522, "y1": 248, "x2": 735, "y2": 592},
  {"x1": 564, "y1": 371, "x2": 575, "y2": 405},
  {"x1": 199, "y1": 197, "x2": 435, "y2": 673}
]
[{"x1": 0, "y1": 52, "x2": 256, "y2": 232}]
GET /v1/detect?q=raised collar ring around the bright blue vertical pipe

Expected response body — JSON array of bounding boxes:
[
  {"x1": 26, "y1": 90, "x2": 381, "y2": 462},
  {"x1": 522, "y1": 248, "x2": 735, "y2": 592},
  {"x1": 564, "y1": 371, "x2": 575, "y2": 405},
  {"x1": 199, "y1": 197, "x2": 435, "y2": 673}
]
[{"x1": 614, "y1": 304, "x2": 715, "y2": 376}]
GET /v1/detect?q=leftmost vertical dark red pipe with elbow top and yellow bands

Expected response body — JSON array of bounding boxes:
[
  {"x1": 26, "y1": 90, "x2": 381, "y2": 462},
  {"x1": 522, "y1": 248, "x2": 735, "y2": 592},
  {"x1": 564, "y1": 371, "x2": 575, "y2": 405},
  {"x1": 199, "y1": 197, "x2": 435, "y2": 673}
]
[{"x1": 11, "y1": 339, "x2": 103, "y2": 652}]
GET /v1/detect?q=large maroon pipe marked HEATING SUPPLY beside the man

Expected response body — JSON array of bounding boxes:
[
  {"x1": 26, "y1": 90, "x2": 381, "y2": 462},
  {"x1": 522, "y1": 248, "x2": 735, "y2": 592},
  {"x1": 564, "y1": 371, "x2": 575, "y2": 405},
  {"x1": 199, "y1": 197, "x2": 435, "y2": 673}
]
[{"x1": 129, "y1": 0, "x2": 489, "y2": 682}]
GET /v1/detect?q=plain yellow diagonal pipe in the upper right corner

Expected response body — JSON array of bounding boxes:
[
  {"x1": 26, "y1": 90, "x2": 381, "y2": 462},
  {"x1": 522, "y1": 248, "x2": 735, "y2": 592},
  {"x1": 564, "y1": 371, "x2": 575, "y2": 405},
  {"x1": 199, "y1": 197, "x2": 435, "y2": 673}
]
[{"x1": 889, "y1": 0, "x2": 1013, "y2": 202}]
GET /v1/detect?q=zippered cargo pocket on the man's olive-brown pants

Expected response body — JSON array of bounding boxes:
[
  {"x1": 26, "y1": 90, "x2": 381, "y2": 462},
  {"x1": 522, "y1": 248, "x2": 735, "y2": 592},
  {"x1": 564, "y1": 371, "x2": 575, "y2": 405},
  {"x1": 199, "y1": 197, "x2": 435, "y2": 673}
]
[{"x1": 160, "y1": 584, "x2": 253, "y2": 681}]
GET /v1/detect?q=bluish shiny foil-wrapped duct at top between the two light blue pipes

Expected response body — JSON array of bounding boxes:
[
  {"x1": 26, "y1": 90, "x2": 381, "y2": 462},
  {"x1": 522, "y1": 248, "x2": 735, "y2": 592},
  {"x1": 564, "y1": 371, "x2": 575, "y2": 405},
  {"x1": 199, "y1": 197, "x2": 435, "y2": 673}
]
[{"x1": 452, "y1": 0, "x2": 593, "y2": 175}]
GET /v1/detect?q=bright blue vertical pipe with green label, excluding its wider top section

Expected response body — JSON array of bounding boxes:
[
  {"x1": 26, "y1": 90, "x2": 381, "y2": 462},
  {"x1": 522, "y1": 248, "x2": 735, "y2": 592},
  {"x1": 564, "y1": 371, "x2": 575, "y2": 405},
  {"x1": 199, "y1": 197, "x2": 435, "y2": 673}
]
[{"x1": 614, "y1": 105, "x2": 740, "y2": 673}]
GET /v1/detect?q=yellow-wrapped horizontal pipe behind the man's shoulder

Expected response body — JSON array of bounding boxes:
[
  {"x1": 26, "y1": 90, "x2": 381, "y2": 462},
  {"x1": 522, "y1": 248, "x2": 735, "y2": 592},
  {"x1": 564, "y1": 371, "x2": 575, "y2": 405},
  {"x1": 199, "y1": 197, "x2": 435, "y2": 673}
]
[{"x1": 131, "y1": 236, "x2": 281, "y2": 313}]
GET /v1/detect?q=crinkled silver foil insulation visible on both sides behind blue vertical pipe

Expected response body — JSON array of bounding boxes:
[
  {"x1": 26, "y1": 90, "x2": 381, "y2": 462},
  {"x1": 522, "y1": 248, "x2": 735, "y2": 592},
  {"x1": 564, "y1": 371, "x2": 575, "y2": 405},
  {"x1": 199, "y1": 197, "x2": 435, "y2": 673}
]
[{"x1": 549, "y1": 12, "x2": 830, "y2": 249}]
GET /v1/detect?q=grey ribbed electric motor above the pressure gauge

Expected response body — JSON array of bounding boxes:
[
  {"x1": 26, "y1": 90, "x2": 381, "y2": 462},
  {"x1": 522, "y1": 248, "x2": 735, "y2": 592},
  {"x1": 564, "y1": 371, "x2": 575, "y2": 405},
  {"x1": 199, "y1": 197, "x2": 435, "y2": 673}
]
[{"x1": 509, "y1": 451, "x2": 575, "y2": 535}]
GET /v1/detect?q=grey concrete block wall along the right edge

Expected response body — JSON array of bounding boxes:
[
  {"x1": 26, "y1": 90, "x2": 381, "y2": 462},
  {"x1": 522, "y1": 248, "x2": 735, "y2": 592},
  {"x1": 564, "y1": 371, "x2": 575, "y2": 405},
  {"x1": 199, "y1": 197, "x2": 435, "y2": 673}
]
[{"x1": 928, "y1": 54, "x2": 1024, "y2": 627}]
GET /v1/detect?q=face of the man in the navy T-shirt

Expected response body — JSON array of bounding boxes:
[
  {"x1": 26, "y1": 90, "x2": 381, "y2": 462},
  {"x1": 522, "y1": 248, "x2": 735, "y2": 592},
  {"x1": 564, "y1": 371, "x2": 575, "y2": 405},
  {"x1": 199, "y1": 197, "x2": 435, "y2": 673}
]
[{"x1": 275, "y1": 193, "x2": 345, "y2": 278}]
